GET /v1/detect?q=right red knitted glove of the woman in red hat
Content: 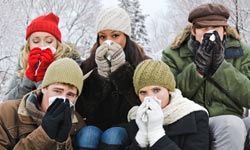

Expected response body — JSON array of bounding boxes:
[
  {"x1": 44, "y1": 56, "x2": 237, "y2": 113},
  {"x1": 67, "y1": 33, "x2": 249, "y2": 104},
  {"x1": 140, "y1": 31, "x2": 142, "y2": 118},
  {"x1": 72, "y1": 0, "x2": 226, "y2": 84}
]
[{"x1": 36, "y1": 48, "x2": 54, "y2": 82}]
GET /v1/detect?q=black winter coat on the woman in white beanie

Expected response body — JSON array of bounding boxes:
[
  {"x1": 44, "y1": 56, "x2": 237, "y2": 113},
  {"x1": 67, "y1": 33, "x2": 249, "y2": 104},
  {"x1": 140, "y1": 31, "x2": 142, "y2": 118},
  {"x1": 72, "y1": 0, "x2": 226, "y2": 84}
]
[{"x1": 76, "y1": 37, "x2": 149, "y2": 130}]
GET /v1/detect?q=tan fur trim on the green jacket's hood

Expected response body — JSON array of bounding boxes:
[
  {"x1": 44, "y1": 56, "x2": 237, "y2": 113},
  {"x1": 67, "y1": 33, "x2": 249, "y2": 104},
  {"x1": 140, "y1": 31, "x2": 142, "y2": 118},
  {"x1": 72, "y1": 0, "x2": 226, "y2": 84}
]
[{"x1": 170, "y1": 24, "x2": 240, "y2": 49}]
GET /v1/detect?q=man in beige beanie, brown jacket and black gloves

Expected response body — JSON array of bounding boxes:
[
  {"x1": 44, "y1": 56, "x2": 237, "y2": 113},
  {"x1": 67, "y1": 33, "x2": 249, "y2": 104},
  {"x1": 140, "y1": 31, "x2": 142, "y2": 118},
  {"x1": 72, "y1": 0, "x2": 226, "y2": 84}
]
[{"x1": 0, "y1": 58, "x2": 85, "y2": 150}]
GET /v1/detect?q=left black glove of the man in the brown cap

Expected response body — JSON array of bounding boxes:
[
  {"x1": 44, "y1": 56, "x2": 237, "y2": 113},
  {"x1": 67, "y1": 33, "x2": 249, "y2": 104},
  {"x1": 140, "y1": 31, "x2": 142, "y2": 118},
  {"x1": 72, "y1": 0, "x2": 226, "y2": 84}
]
[{"x1": 194, "y1": 33, "x2": 213, "y2": 76}]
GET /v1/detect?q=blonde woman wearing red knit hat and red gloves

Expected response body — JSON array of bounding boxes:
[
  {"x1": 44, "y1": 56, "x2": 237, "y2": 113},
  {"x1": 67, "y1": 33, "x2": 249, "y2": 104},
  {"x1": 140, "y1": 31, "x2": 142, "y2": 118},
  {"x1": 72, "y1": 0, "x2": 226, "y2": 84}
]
[{"x1": 4, "y1": 12, "x2": 81, "y2": 100}]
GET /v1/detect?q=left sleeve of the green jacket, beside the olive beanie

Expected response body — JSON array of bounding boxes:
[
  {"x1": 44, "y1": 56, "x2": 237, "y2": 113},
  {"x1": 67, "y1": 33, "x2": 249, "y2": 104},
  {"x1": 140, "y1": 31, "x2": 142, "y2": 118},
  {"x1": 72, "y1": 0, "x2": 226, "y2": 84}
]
[{"x1": 162, "y1": 49, "x2": 205, "y2": 97}]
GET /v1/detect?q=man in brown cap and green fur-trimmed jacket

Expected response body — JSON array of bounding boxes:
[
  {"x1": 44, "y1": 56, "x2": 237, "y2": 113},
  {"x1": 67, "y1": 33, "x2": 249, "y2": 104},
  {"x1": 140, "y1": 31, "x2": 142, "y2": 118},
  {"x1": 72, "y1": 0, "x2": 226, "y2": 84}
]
[{"x1": 162, "y1": 4, "x2": 250, "y2": 150}]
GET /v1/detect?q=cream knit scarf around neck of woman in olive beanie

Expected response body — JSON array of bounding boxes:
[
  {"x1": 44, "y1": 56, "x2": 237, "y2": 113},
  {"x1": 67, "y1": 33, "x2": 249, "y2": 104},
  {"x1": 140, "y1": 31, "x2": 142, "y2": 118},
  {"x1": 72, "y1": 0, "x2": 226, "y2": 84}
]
[{"x1": 128, "y1": 89, "x2": 208, "y2": 125}]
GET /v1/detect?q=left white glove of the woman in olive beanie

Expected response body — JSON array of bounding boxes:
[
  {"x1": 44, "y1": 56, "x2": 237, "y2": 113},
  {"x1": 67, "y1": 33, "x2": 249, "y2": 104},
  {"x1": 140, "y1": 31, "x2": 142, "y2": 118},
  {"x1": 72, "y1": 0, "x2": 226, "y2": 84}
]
[{"x1": 135, "y1": 101, "x2": 149, "y2": 148}]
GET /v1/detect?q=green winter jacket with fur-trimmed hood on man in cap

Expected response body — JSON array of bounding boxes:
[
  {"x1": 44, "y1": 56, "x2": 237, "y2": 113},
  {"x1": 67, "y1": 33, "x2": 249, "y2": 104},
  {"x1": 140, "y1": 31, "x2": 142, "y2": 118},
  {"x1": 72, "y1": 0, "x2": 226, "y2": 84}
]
[{"x1": 162, "y1": 27, "x2": 250, "y2": 116}]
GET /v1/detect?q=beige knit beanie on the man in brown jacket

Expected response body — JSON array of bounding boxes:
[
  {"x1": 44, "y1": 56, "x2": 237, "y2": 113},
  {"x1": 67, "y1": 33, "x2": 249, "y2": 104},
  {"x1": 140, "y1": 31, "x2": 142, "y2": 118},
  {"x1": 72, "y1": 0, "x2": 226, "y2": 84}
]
[{"x1": 42, "y1": 58, "x2": 83, "y2": 96}]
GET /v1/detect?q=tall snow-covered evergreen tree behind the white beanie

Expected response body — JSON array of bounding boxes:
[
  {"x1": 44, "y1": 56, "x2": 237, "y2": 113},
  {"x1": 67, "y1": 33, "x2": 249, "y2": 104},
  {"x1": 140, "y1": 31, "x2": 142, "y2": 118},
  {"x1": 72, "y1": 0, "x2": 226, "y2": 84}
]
[{"x1": 118, "y1": 0, "x2": 149, "y2": 50}]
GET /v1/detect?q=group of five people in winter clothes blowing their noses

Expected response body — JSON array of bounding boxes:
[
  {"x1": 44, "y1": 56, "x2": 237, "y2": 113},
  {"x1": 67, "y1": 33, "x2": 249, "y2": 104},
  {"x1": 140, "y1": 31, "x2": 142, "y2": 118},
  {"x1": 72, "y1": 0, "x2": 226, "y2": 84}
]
[{"x1": 0, "y1": 3, "x2": 250, "y2": 150}]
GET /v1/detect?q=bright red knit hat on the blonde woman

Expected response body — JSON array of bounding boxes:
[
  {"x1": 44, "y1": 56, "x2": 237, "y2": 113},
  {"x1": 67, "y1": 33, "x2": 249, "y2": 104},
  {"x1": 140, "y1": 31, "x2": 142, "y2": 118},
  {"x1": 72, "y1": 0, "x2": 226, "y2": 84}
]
[{"x1": 26, "y1": 12, "x2": 61, "y2": 42}]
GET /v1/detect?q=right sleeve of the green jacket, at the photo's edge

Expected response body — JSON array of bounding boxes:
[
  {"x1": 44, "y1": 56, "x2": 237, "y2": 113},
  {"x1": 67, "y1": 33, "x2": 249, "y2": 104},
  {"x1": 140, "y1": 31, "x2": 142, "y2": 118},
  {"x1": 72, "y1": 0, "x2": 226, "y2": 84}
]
[{"x1": 211, "y1": 53, "x2": 250, "y2": 108}]
